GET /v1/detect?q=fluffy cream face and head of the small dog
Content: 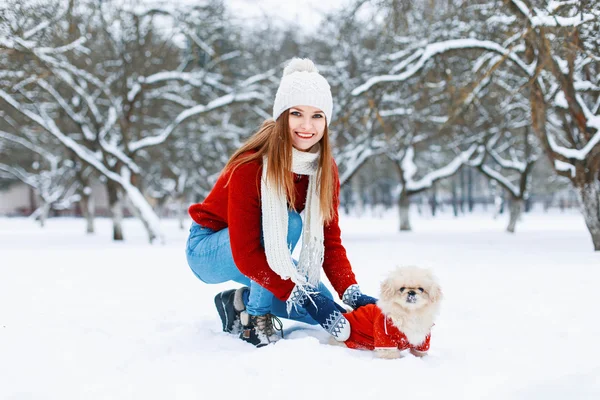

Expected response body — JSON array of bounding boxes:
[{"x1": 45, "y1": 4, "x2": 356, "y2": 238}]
[{"x1": 381, "y1": 267, "x2": 442, "y2": 311}]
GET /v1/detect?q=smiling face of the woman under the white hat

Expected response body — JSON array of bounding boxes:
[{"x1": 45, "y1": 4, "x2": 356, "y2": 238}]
[{"x1": 289, "y1": 106, "x2": 327, "y2": 151}]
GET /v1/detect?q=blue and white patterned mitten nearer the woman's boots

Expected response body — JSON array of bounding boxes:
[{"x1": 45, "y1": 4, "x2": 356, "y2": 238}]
[{"x1": 287, "y1": 286, "x2": 350, "y2": 342}]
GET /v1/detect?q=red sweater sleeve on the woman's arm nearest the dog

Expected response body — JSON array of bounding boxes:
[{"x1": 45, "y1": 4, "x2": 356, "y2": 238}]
[{"x1": 323, "y1": 162, "x2": 356, "y2": 298}]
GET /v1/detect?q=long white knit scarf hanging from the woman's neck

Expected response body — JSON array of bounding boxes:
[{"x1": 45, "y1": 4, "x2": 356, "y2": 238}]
[{"x1": 260, "y1": 144, "x2": 324, "y2": 291}]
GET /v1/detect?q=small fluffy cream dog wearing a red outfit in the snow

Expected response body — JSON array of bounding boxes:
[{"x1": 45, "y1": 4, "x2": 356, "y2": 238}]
[{"x1": 337, "y1": 267, "x2": 442, "y2": 358}]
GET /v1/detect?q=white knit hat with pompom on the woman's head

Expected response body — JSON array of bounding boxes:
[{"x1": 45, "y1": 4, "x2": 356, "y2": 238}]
[{"x1": 273, "y1": 58, "x2": 333, "y2": 126}]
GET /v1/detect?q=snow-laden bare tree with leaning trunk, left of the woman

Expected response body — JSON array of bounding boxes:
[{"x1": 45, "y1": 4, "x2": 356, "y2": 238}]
[{"x1": 0, "y1": 2, "x2": 262, "y2": 241}]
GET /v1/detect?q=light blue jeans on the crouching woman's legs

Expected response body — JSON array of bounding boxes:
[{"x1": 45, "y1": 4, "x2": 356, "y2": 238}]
[{"x1": 186, "y1": 211, "x2": 333, "y2": 325}]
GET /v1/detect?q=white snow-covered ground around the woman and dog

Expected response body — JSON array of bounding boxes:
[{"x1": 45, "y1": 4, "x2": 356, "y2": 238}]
[{"x1": 0, "y1": 212, "x2": 600, "y2": 400}]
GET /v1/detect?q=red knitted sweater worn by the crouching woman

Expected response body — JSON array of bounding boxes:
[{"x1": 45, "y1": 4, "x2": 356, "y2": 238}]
[{"x1": 189, "y1": 156, "x2": 356, "y2": 300}]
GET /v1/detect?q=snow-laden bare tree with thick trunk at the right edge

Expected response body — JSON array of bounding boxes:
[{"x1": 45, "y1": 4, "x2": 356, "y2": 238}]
[{"x1": 354, "y1": 0, "x2": 600, "y2": 250}]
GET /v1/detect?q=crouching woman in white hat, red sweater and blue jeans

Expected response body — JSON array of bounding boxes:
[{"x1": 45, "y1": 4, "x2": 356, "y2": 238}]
[{"x1": 187, "y1": 58, "x2": 377, "y2": 347}]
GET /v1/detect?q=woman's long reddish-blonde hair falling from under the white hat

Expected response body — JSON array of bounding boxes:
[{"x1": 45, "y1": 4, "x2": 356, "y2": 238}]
[{"x1": 223, "y1": 110, "x2": 335, "y2": 223}]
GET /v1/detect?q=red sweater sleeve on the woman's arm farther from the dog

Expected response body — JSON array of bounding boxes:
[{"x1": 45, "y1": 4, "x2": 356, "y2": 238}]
[{"x1": 227, "y1": 163, "x2": 294, "y2": 301}]
